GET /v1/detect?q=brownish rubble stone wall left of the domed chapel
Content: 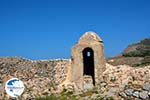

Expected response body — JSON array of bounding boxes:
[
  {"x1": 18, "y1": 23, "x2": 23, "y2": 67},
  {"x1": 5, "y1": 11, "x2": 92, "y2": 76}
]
[{"x1": 0, "y1": 57, "x2": 71, "y2": 99}]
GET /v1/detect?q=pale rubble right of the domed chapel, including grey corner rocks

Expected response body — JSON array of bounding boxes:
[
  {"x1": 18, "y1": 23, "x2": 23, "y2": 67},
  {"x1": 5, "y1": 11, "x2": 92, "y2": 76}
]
[{"x1": 103, "y1": 64, "x2": 150, "y2": 100}]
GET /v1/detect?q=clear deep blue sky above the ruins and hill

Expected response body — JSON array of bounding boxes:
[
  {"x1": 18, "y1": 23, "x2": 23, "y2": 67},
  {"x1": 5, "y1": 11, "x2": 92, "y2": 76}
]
[{"x1": 0, "y1": 0, "x2": 150, "y2": 59}]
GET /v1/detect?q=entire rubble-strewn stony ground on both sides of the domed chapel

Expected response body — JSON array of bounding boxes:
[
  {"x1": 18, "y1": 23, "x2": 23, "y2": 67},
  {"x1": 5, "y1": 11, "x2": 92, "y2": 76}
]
[{"x1": 0, "y1": 57, "x2": 150, "y2": 100}]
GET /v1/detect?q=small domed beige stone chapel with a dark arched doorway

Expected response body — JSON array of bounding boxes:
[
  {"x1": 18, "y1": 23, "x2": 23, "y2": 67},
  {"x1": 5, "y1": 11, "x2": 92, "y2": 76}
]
[{"x1": 71, "y1": 32, "x2": 106, "y2": 90}]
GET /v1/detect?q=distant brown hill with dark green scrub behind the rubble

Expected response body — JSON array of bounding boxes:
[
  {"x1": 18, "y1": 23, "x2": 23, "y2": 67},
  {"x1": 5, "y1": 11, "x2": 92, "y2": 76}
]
[{"x1": 107, "y1": 38, "x2": 150, "y2": 66}]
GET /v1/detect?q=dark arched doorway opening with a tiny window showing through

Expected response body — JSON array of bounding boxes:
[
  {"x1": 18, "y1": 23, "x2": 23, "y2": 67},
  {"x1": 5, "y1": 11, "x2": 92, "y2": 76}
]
[{"x1": 82, "y1": 47, "x2": 95, "y2": 85}]
